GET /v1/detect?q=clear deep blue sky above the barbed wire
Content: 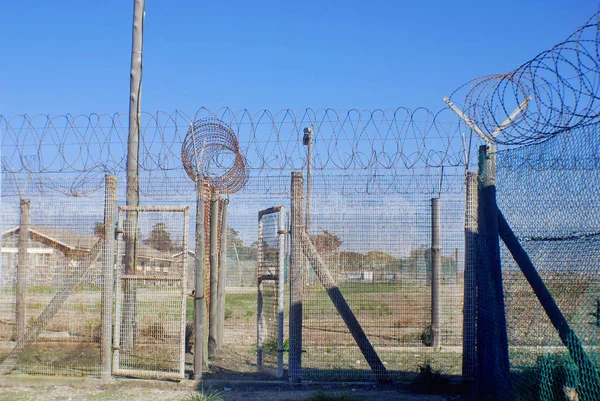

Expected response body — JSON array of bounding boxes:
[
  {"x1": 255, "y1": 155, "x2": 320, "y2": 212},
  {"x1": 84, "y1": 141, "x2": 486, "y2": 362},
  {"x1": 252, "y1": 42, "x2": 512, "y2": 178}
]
[{"x1": 0, "y1": 0, "x2": 598, "y2": 118}]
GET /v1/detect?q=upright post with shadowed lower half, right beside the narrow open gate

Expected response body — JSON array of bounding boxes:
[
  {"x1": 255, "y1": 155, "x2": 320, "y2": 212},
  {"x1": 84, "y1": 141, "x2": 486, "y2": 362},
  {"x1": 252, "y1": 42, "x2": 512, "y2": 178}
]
[{"x1": 289, "y1": 172, "x2": 304, "y2": 382}]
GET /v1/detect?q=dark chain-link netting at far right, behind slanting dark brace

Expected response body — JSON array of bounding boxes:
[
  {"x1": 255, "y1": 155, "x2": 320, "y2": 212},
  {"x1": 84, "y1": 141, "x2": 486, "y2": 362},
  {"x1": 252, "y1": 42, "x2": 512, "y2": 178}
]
[{"x1": 497, "y1": 126, "x2": 600, "y2": 400}]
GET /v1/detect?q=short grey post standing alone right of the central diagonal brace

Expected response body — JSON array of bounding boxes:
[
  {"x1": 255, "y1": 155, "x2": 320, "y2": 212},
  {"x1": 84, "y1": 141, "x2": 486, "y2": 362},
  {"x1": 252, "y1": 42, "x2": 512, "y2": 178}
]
[{"x1": 431, "y1": 198, "x2": 442, "y2": 350}]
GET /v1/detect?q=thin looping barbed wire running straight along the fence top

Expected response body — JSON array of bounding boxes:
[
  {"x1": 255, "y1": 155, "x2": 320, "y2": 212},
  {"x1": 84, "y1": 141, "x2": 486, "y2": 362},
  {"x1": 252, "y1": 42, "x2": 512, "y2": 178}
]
[{"x1": 0, "y1": 108, "x2": 465, "y2": 174}]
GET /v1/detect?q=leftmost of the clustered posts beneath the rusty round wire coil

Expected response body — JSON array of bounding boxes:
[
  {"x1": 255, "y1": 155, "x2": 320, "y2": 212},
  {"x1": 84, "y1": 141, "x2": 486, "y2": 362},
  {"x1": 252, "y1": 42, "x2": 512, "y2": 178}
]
[{"x1": 194, "y1": 178, "x2": 206, "y2": 380}]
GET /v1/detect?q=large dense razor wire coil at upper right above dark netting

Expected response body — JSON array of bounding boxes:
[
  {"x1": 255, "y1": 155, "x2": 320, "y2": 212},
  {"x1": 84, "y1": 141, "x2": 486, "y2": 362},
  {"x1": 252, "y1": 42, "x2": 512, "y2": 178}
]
[{"x1": 451, "y1": 13, "x2": 600, "y2": 145}]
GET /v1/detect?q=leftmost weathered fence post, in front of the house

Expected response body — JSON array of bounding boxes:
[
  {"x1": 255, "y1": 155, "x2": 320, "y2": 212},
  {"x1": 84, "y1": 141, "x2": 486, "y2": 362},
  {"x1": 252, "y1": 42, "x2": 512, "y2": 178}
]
[{"x1": 15, "y1": 199, "x2": 31, "y2": 341}]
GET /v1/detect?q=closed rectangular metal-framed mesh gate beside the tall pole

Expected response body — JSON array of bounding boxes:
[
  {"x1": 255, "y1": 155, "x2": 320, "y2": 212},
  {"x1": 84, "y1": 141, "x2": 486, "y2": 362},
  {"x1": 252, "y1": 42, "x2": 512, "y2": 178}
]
[{"x1": 113, "y1": 206, "x2": 189, "y2": 379}]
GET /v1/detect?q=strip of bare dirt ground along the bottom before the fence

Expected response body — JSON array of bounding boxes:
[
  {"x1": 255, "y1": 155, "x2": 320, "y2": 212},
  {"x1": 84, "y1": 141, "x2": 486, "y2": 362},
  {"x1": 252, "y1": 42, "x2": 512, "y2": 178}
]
[{"x1": 0, "y1": 377, "x2": 466, "y2": 401}]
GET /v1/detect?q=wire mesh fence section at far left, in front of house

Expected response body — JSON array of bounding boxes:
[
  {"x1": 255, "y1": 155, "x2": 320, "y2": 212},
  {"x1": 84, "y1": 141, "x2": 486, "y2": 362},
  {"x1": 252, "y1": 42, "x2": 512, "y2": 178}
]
[{"x1": 0, "y1": 178, "x2": 104, "y2": 376}]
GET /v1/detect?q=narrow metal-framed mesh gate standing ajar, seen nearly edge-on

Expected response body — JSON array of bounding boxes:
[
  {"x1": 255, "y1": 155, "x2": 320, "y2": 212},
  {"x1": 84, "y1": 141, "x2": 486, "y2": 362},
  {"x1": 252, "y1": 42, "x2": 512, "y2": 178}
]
[{"x1": 256, "y1": 206, "x2": 288, "y2": 377}]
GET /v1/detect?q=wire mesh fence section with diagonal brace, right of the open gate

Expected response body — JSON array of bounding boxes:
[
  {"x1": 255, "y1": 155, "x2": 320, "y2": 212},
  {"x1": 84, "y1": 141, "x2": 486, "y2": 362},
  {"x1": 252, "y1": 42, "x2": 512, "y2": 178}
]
[{"x1": 303, "y1": 175, "x2": 464, "y2": 379}]
